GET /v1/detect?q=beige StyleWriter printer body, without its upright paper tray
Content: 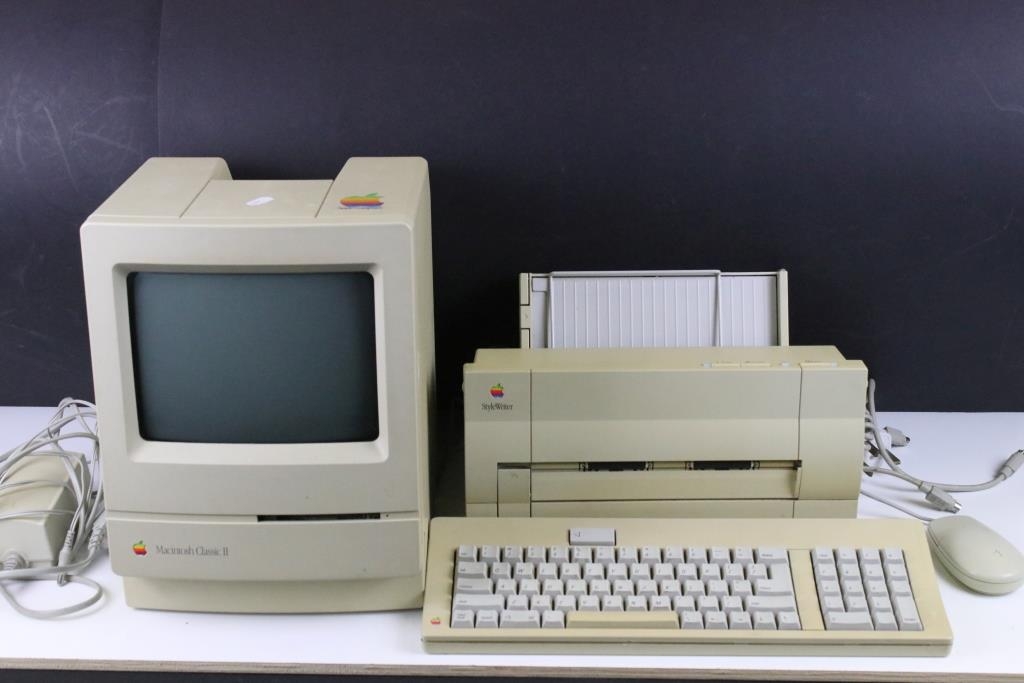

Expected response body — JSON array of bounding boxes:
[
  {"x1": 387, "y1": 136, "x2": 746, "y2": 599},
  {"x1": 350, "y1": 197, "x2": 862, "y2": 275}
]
[{"x1": 464, "y1": 346, "x2": 867, "y2": 517}]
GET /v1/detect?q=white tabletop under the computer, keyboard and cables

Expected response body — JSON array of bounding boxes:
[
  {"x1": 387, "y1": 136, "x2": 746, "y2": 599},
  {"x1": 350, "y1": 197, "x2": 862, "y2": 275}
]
[{"x1": 0, "y1": 408, "x2": 1024, "y2": 681}]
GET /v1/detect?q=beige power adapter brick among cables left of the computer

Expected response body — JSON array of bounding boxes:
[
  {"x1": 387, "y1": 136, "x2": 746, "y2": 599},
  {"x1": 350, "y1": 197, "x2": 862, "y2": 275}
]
[{"x1": 0, "y1": 456, "x2": 76, "y2": 566}]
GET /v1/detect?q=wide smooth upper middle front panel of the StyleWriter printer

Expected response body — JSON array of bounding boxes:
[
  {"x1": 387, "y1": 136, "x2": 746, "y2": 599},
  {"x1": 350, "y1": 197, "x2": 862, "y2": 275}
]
[{"x1": 532, "y1": 366, "x2": 801, "y2": 463}]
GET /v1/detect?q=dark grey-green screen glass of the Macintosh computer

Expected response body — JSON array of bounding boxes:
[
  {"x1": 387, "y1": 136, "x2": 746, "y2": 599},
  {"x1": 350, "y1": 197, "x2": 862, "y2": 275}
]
[{"x1": 128, "y1": 272, "x2": 379, "y2": 443}]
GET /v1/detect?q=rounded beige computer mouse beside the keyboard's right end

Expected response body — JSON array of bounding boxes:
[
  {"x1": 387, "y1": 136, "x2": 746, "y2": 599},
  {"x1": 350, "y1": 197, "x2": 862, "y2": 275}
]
[{"x1": 928, "y1": 515, "x2": 1024, "y2": 595}]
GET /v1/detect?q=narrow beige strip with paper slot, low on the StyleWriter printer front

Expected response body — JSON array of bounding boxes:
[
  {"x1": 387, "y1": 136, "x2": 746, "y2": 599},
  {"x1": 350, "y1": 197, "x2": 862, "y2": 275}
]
[{"x1": 520, "y1": 461, "x2": 800, "y2": 503}]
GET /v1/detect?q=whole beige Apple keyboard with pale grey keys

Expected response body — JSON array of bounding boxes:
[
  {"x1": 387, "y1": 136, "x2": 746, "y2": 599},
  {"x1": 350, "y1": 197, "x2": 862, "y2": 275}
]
[{"x1": 423, "y1": 517, "x2": 952, "y2": 655}]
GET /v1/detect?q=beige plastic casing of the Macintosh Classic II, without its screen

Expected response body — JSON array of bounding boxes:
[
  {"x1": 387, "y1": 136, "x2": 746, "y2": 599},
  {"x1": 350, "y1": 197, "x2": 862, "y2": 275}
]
[{"x1": 82, "y1": 158, "x2": 434, "y2": 611}]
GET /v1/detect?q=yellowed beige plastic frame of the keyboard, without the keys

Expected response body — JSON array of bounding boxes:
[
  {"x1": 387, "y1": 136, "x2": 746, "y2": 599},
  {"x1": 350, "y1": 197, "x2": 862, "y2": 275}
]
[{"x1": 422, "y1": 517, "x2": 952, "y2": 656}]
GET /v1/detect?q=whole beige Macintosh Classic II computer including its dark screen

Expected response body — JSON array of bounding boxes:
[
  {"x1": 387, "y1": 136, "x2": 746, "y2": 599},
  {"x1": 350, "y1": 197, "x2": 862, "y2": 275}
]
[{"x1": 82, "y1": 158, "x2": 434, "y2": 612}]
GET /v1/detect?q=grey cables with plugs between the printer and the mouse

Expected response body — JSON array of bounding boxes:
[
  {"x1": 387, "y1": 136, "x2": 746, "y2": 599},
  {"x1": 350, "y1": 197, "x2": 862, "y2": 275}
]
[{"x1": 863, "y1": 380, "x2": 1024, "y2": 516}]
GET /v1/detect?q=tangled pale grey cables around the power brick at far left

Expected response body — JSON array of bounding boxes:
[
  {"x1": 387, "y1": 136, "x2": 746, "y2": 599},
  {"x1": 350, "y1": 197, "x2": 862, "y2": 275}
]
[{"x1": 0, "y1": 398, "x2": 106, "y2": 618}]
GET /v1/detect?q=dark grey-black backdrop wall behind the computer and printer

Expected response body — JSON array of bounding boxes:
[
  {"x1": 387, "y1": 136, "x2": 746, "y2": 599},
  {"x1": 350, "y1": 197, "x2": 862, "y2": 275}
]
[{"x1": 0, "y1": 0, "x2": 1024, "y2": 421}]
